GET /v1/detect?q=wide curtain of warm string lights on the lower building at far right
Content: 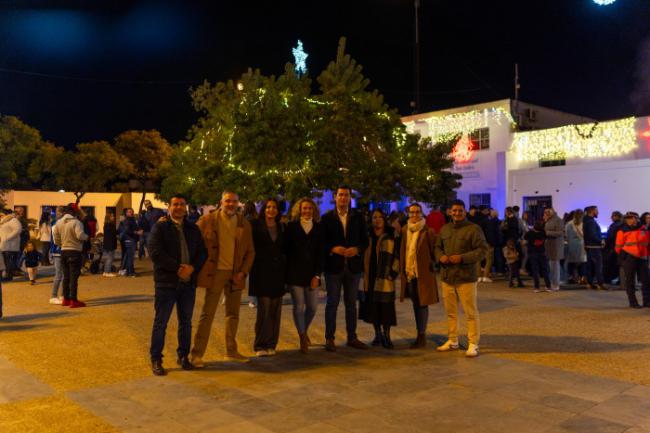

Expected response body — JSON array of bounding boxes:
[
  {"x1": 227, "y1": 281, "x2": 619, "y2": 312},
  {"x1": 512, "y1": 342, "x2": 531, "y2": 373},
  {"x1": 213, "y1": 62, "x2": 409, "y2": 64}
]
[{"x1": 512, "y1": 117, "x2": 637, "y2": 161}]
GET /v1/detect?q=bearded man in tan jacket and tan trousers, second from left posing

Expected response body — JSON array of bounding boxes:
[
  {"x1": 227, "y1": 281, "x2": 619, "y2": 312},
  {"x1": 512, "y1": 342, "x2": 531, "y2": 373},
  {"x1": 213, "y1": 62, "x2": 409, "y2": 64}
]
[{"x1": 192, "y1": 191, "x2": 255, "y2": 367}]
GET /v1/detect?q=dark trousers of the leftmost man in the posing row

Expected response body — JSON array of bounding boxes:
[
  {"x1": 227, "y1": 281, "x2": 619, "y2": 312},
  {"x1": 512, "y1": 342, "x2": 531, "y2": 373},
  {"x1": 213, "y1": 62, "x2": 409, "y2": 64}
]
[{"x1": 150, "y1": 283, "x2": 196, "y2": 361}]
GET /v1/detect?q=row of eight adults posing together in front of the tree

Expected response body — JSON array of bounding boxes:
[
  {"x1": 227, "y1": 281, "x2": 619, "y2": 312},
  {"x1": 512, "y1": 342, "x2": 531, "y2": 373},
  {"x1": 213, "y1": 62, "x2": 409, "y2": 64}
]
[{"x1": 148, "y1": 186, "x2": 488, "y2": 375}]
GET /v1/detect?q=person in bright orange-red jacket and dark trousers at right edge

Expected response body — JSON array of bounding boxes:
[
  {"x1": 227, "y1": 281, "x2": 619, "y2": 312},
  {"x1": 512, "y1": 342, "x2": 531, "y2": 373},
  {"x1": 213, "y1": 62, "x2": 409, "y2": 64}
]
[{"x1": 615, "y1": 212, "x2": 650, "y2": 308}]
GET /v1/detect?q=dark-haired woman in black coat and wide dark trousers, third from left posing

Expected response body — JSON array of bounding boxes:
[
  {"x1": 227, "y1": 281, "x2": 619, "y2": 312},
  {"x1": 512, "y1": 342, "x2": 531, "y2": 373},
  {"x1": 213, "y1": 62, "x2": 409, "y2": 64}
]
[{"x1": 249, "y1": 199, "x2": 286, "y2": 356}]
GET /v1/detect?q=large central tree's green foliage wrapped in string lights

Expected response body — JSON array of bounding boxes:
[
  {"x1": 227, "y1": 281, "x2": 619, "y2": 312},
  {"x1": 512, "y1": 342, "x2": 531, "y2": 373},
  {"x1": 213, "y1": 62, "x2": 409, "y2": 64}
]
[{"x1": 161, "y1": 38, "x2": 459, "y2": 203}]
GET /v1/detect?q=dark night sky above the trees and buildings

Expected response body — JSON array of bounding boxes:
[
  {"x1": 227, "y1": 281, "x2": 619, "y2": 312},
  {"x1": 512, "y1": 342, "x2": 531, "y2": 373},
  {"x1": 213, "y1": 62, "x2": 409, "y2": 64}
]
[{"x1": 0, "y1": 0, "x2": 650, "y2": 147}]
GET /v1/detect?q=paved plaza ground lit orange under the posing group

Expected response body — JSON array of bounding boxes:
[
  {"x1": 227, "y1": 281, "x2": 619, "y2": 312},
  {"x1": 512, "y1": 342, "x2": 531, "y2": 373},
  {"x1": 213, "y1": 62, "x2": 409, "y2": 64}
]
[{"x1": 0, "y1": 261, "x2": 650, "y2": 433}]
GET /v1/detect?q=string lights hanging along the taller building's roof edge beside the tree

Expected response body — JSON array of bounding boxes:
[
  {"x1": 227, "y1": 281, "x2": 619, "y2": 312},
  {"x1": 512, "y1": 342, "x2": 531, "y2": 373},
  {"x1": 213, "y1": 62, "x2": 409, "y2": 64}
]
[{"x1": 405, "y1": 108, "x2": 514, "y2": 143}]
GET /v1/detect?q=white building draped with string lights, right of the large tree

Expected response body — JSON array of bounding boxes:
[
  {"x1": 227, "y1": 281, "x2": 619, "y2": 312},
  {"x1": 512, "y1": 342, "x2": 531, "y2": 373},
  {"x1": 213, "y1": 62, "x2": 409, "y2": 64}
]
[{"x1": 402, "y1": 99, "x2": 650, "y2": 227}]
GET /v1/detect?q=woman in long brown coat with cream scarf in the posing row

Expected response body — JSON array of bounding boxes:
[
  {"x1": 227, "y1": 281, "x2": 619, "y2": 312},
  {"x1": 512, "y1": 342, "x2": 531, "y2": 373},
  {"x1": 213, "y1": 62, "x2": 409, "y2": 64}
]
[{"x1": 399, "y1": 203, "x2": 438, "y2": 349}]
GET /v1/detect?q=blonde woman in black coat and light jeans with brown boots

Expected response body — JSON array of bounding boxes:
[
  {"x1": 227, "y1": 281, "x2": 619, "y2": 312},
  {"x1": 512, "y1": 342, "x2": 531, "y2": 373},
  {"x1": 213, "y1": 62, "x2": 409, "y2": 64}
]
[{"x1": 285, "y1": 198, "x2": 323, "y2": 353}]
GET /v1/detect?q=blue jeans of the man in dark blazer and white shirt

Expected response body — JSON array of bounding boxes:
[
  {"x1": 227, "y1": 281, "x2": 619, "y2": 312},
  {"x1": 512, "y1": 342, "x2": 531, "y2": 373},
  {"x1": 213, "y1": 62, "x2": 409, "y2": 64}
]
[{"x1": 325, "y1": 270, "x2": 363, "y2": 341}]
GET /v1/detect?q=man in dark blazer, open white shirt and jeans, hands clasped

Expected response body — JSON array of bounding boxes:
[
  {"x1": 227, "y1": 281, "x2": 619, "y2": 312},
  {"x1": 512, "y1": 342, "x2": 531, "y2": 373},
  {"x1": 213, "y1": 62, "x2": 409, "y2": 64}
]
[{"x1": 322, "y1": 186, "x2": 368, "y2": 352}]
